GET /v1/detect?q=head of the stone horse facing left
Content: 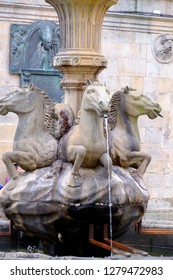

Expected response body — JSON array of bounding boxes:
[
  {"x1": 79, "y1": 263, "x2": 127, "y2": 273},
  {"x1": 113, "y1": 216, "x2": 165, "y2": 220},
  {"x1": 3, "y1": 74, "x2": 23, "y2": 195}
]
[{"x1": 0, "y1": 84, "x2": 44, "y2": 115}]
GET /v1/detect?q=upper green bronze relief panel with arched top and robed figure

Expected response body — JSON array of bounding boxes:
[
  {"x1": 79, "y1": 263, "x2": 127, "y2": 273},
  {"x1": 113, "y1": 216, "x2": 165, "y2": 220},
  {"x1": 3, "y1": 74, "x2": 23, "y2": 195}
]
[{"x1": 10, "y1": 20, "x2": 60, "y2": 73}]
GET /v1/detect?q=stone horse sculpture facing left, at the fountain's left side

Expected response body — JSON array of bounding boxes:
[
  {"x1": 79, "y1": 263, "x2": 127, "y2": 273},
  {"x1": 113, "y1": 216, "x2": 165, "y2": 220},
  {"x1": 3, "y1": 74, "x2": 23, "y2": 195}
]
[{"x1": 0, "y1": 84, "x2": 73, "y2": 179}]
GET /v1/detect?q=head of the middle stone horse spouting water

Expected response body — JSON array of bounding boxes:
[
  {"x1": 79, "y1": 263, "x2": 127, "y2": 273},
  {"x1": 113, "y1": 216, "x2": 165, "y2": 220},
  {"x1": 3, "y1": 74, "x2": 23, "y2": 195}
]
[{"x1": 81, "y1": 81, "x2": 110, "y2": 117}]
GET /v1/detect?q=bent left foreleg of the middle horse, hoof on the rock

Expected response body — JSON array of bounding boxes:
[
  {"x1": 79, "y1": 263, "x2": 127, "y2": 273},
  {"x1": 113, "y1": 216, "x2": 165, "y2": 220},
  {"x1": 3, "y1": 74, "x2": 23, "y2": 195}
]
[{"x1": 67, "y1": 145, "x2": 86, "y2": 187}]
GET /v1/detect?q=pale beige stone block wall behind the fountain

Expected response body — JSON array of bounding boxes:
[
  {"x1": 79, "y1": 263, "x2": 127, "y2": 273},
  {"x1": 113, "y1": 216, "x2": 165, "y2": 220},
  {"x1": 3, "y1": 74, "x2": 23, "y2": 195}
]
[{"x1": 0, "y1": 0, "x2": 173, "y2": 226}]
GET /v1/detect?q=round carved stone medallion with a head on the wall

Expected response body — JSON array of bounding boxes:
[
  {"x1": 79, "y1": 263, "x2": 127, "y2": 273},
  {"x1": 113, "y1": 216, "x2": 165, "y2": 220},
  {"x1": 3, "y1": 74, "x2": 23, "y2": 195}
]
[{"x1": 153, "y1": 34, "x2": 173, "y2": 63}]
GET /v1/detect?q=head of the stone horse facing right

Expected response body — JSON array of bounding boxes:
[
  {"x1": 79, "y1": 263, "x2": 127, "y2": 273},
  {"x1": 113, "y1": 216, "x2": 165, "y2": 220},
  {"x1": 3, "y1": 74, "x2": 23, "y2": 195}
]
[{"x1": 121, "y1": 86, "x2": 162, "y2": 119}]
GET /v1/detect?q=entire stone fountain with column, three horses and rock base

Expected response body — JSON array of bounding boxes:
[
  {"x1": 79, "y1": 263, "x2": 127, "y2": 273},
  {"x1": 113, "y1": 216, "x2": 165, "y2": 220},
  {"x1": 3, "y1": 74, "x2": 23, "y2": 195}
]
[{"x1": 0, "y1": 0, "x2": 161, "y2": 256}]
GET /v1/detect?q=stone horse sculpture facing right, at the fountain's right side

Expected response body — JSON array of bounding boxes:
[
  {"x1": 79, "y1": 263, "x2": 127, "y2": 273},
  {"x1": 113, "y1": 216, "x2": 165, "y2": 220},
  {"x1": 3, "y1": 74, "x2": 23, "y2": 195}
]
[{"x1": 108, "y1": 87, "x2": 161, "y2": 182}]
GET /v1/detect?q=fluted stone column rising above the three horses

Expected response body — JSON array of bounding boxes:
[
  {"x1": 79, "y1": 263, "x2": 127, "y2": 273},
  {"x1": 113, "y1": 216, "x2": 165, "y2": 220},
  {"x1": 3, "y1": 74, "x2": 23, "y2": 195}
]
[{"x1": 45, "y1": 0, "x2": 118, "y2": 115}]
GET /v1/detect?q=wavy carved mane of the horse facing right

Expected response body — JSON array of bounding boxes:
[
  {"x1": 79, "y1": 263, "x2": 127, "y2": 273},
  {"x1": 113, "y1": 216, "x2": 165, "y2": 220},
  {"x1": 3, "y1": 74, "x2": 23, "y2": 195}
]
[{"x1": 108, "y1": 86, "x2": 136, "y2": 130}]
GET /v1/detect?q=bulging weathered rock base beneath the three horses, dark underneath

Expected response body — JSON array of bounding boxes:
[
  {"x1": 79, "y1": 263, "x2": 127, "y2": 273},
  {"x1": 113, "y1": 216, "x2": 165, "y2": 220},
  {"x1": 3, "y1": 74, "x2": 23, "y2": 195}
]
[{"x1": 0, "y1": 161, "x2": 149, "y2": 241}]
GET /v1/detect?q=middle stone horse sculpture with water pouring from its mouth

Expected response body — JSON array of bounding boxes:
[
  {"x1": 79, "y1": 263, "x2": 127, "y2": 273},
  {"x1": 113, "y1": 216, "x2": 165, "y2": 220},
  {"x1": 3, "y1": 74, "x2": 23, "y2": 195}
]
[{"x1": 59, "y1": 82, "x2": 111, "y2": 187}]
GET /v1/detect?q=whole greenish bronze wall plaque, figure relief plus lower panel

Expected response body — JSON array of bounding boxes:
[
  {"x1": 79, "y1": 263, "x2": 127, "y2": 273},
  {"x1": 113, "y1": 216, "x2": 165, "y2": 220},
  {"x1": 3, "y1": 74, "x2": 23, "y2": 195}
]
[{"x1": 10, "y1": 20, "x2": 64, "y2": 102}]
